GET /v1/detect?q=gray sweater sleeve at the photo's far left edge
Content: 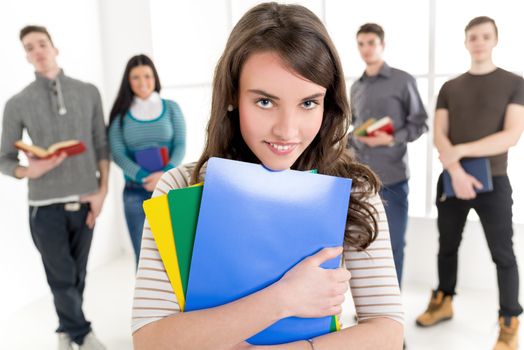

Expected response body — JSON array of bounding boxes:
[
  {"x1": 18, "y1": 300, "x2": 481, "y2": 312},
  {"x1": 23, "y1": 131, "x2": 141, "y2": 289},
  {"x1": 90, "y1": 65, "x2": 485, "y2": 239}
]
[{"x1": 0, "y1": 100, "x2": 24, "y2": 177}]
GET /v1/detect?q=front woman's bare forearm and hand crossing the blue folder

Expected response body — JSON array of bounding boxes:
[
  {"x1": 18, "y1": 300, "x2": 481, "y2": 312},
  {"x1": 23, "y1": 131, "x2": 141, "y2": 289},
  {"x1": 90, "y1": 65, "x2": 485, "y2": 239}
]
[{"x1": 133, "y1": 248, "x2": 350, "y2": 350}]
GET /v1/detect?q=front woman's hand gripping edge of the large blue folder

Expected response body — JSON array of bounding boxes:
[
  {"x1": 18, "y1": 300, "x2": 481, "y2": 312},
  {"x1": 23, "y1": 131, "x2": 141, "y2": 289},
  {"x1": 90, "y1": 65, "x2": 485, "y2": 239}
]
[{"x1": 275, "y1": 247, "x2": 351, "y2": 317}]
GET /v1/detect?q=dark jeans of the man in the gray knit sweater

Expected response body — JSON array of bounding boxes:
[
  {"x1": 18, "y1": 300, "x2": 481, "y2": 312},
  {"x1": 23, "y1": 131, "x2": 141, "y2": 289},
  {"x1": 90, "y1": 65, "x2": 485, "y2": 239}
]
[{"x1": 29, "y1": 204, "x2": 93, "y2": 344}]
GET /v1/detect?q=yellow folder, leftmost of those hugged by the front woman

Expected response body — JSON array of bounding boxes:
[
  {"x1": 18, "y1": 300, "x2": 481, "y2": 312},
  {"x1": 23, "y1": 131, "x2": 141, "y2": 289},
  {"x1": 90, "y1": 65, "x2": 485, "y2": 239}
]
[{"x1": 143, "y1": 195, "x2": 186, "y2": 311}]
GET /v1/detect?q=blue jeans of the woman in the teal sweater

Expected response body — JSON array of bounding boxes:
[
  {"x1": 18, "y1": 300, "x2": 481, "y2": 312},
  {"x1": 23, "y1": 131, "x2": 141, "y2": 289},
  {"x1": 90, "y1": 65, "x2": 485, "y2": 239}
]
[{"x1": 123, "y1": 181, "x2": 152, "y2": 264}]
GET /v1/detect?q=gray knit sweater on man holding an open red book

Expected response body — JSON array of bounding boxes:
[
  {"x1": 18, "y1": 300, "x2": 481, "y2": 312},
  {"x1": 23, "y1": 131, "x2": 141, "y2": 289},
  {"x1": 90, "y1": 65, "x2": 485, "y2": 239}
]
[{"x1": 0, "y1": 72, "x2": 108, "y2": 201}]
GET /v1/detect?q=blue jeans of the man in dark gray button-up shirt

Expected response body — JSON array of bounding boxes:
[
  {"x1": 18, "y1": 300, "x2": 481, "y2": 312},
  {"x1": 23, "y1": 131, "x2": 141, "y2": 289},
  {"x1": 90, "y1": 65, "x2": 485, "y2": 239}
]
[{"x1": 380, "y1": 180, "x2": 409, "y2": 286}]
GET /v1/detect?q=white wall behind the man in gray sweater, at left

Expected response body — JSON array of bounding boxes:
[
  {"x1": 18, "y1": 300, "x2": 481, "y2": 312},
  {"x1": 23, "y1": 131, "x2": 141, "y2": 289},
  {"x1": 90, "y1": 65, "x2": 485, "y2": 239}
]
[{"x1": 0, "y1": 0, "x2": 151, "y2": 320}]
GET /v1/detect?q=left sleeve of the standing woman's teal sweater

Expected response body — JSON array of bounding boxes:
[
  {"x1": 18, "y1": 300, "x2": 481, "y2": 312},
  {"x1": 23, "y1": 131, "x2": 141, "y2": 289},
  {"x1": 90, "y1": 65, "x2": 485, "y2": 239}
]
[{"x1": 109, "y1": 118, "x2": 149, "y2": 183}]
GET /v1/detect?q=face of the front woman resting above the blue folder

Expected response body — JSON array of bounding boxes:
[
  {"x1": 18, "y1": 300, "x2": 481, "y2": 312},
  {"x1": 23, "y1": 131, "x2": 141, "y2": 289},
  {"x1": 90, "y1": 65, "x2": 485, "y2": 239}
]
[{"x1": 238, "y1": 52, "x2": 326, "y2": 170}]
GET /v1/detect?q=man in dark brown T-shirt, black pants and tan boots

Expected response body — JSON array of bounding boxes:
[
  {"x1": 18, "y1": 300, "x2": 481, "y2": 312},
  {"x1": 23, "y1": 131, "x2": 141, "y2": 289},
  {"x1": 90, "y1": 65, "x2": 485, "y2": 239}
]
[{"x1": 416, "y1": 16, "x2": 524, "y2": 350}]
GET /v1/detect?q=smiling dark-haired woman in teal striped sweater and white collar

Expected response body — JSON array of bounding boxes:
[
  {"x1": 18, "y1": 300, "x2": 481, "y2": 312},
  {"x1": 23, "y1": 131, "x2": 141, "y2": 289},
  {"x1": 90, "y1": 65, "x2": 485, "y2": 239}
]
[{"x1": 109, "y1": 55, "x2": 186, "y2": 263}]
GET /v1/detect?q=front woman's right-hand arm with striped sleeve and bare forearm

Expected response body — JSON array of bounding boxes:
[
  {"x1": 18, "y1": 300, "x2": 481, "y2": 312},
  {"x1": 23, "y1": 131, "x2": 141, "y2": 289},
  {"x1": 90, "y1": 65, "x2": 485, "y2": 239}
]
[{"x1": 324, "y1": 195, "x2": 404, "y2": 350}]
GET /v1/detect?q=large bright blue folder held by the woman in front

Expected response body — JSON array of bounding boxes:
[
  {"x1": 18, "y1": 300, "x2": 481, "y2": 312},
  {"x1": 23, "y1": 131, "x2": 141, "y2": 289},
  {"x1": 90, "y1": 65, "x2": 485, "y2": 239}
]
[{"x1": 186, "y1": 158, "x2": 351, "y2": 345}]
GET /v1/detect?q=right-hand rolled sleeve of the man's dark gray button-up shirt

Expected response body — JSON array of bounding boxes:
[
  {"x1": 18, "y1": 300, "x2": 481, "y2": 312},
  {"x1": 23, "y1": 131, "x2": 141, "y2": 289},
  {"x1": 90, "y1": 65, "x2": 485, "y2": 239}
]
[{"x1": 395, "y1": 77, "x2": 428, "y2": 142}]
